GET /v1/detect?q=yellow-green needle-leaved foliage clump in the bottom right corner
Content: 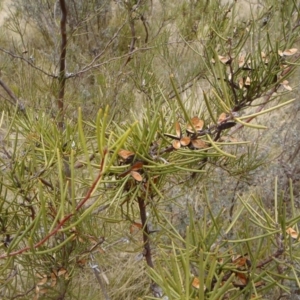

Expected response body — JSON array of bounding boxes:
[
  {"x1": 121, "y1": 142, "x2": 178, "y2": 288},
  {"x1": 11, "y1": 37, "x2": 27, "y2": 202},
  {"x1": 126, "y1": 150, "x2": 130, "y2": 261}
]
[{"x1": 147, "y1": 182, "x2": 299, "y2": 299}]
